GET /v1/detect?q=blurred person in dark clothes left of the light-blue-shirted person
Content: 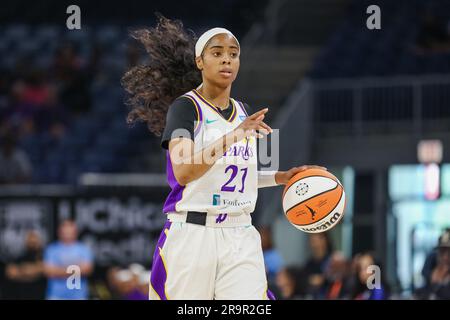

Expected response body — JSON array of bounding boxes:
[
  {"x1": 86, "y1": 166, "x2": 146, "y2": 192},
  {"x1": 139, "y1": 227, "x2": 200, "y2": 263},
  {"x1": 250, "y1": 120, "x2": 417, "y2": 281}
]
[{"x1": 5, "y1": 231, "x2": 46, "y2": 300}]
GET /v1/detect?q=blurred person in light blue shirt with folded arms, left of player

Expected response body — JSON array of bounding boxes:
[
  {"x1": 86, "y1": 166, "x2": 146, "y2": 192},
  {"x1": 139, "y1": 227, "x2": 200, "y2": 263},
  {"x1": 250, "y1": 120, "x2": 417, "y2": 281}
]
[{"x1": 44, "y1": 220, "x2": 93, "y2": 300}]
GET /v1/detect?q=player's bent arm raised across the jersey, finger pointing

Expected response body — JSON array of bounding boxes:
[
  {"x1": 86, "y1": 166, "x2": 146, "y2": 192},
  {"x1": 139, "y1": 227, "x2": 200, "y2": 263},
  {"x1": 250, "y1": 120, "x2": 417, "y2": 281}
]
[{"x1": 169, "y1": 108, "x2": 272, "y2": 185}]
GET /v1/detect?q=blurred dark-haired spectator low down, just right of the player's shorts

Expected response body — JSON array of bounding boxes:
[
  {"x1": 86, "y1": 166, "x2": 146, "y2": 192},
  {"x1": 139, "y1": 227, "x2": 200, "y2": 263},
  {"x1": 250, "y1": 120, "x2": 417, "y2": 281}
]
[{"x1": 276, "y1": 266, "x2": 311, "y2": 300}]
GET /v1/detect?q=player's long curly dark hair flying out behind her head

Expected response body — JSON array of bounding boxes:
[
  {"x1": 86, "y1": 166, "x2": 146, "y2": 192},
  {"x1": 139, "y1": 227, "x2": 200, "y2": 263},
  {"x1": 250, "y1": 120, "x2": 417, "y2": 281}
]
[{"x1": 121, "y1": 13, "x2": 202, "y2": 136}]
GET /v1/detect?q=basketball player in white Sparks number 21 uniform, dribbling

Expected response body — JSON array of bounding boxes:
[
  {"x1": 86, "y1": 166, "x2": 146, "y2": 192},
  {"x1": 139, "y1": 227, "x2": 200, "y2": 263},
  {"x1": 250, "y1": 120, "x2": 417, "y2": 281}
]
[{"x1": 122, "y1": 17, "x2": 321, "y2": 300}]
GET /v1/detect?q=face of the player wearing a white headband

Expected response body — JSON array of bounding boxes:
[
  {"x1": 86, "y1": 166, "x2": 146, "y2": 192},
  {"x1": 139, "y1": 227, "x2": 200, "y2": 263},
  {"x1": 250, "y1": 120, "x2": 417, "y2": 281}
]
[{"x1": 197, "y1": 34, "x2": 240, "y2": 88}]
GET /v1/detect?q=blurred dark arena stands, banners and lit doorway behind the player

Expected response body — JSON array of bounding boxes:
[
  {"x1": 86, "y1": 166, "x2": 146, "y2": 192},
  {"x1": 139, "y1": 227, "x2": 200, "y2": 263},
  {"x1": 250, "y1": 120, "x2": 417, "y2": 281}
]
[{"x1": 0, "y1": 0, "x2": 450, "y2": 299}]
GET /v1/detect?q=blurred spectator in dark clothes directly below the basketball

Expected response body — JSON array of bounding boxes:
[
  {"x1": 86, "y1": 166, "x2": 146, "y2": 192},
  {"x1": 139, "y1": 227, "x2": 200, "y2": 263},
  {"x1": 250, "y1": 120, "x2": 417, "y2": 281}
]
[{"x1": 304, "y1": 232, "x2": 333, "y2": 299}]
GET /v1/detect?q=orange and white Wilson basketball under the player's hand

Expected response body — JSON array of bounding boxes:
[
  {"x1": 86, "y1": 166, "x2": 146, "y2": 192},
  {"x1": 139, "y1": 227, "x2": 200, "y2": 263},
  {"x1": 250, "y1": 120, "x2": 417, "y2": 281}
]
[{"x1": 282, "y1": 169, "x2": 345, "y2": 233}]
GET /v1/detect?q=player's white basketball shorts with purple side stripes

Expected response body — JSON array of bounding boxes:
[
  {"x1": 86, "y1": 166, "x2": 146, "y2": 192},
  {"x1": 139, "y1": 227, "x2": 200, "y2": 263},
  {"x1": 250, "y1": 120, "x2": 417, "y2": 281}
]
[{"x1": 149, "y1": 215, "x2": 273, "y2": 300}]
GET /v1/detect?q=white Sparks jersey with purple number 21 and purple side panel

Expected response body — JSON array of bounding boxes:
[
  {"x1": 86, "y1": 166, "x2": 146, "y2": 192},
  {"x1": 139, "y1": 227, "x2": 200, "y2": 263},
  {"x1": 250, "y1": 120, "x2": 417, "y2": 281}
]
[{"x1": 164, "y1": 90, "x2": 258, "y2": 215}]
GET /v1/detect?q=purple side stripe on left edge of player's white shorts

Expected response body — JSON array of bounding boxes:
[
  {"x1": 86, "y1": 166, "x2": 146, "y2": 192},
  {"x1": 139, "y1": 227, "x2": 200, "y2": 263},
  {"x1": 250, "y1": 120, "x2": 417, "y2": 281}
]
[{"x1": 150, "y1": 220, "x2": 172, "y2": 300}]
